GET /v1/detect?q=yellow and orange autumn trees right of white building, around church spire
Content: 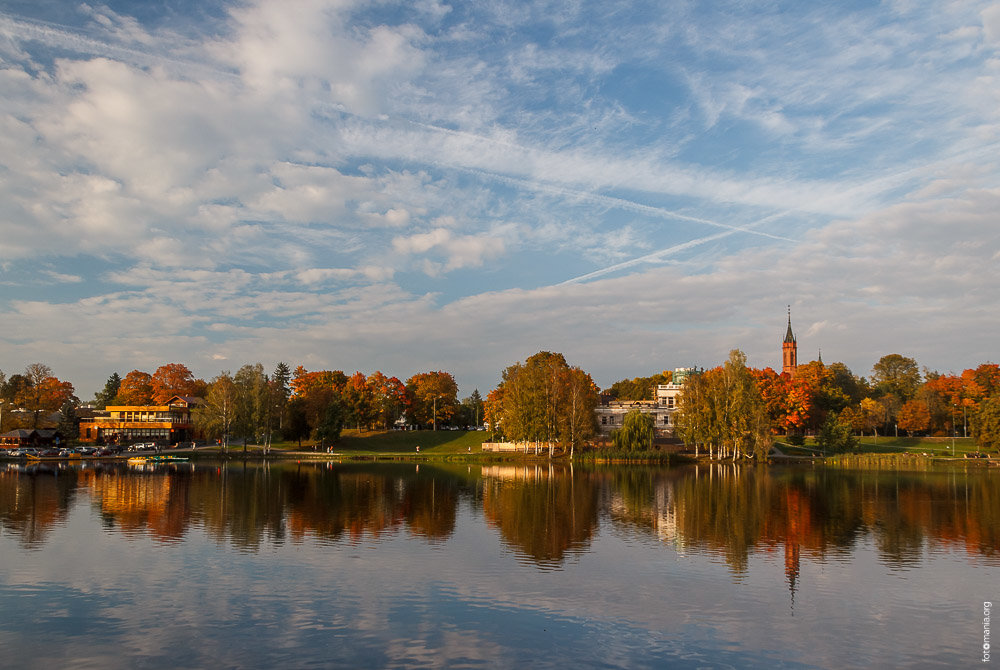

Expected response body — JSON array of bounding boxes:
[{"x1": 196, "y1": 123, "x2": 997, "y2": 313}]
[{"x1": 677, "y1": 350, "x2": 1000, "y2": 459}]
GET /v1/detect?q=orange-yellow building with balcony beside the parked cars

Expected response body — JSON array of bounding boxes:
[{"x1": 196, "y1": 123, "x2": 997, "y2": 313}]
[{"x1": 80, "y1": 395, "x2": 201, "y2": 444}]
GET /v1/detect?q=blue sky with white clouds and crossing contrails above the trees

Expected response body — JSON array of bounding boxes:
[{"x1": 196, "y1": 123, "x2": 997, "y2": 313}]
[{"x1": 0, "y1": 0, "x2": 1000, "y2": 399}]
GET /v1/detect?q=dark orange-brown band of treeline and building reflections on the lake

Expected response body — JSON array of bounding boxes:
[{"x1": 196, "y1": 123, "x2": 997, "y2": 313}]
[{"x1": 0, "y1": 463, "x2": 1000, "y2": 576}]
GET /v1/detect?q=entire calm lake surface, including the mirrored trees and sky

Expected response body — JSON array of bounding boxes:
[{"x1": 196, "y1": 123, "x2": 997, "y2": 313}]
[{"x1": 0, "y1": 463, "x2": 1000, "y2": 668}]
